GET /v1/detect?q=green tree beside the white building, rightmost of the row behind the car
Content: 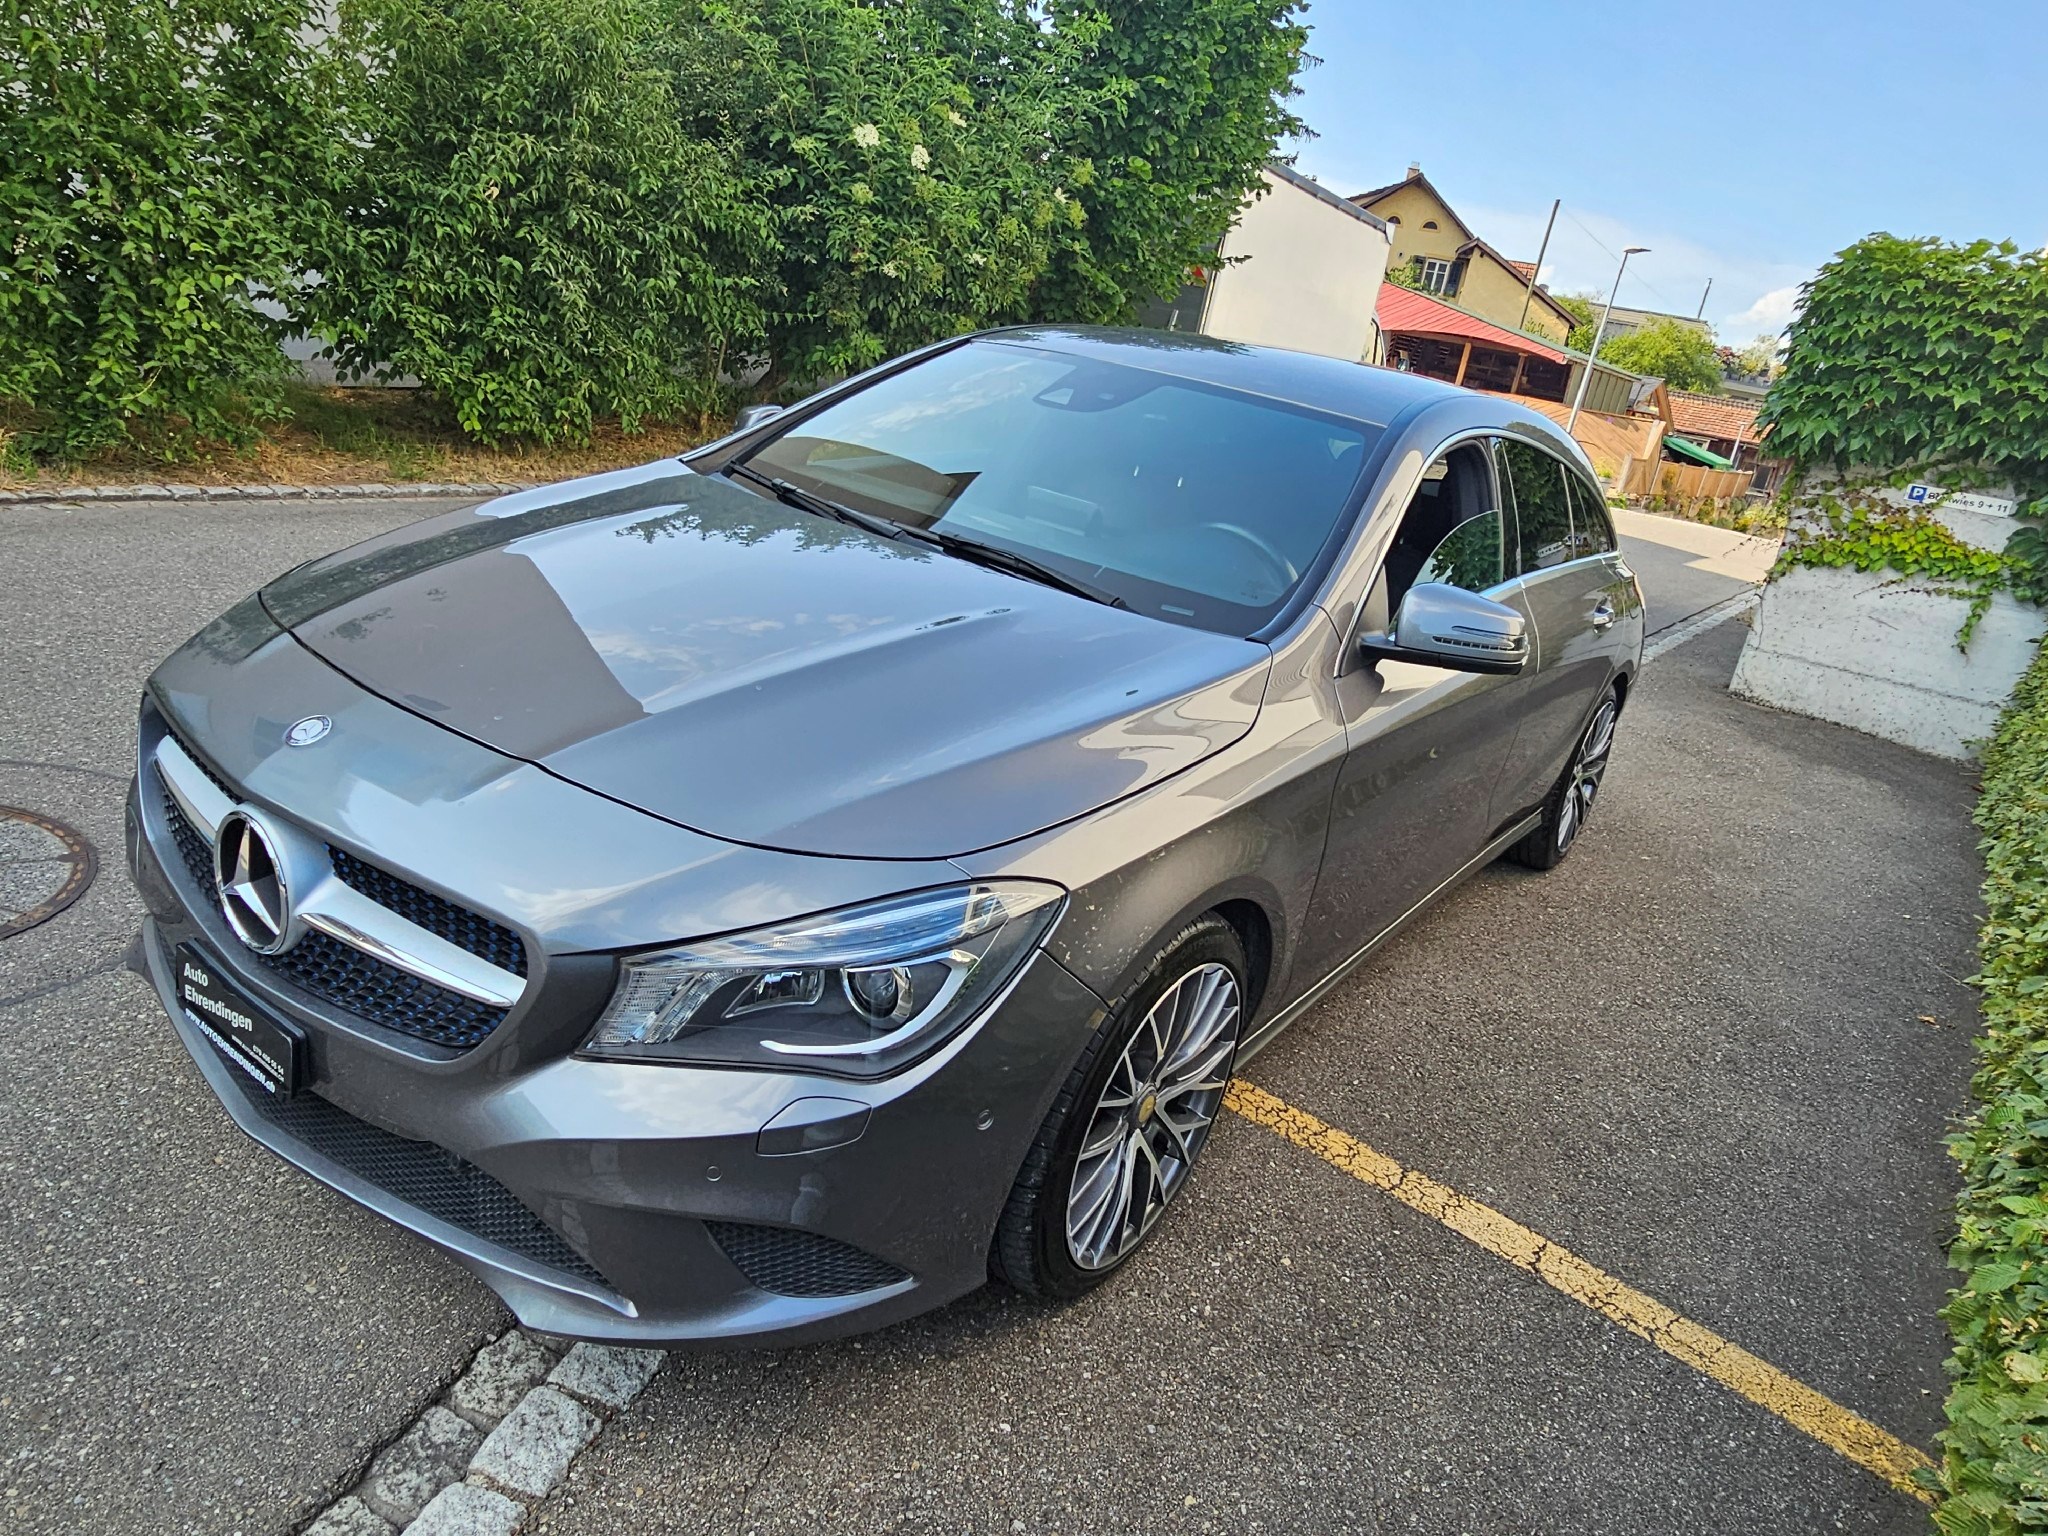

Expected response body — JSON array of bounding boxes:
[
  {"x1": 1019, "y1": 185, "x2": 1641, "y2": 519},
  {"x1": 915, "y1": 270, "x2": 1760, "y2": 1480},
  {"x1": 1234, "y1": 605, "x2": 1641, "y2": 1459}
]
[{"x1": 1034, "y1": 0, "x2": 1309, "y2": 322}]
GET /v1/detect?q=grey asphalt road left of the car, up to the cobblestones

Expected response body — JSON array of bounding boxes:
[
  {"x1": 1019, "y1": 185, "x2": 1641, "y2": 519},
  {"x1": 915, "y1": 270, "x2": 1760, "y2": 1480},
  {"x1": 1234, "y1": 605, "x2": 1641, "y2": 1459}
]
[{"x1": 0, "y1": 502, "x2": 504, "y2": 1536}]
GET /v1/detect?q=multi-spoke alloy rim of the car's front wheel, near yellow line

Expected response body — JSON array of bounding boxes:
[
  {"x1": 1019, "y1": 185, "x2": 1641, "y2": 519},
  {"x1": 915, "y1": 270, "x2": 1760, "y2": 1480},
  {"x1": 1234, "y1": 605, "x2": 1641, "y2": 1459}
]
[{"x1": 1067, "y1": 963, "x2": 1241, "y2": 1270}]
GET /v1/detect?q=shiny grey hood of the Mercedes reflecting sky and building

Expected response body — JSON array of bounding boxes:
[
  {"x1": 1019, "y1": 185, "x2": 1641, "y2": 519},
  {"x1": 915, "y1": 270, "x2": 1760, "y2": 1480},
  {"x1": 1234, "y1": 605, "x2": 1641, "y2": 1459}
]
[{"x1": 262, "y1": 461, "x2": 1270, "y2": 858}]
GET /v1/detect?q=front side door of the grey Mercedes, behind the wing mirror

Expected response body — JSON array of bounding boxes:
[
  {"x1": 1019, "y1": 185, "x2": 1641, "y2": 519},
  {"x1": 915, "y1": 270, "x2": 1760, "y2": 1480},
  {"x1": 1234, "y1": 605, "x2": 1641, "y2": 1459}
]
[{"x1": 1298, "y1": 438, "x2": 1528, "y2": 975}]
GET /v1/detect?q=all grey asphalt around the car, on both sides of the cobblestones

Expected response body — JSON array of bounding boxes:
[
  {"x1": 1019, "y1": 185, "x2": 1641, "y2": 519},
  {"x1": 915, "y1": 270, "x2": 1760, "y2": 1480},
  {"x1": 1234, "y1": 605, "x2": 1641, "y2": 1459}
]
[{"x1": 0, "y1": 502, "x2": 1978, "y2": 1536}]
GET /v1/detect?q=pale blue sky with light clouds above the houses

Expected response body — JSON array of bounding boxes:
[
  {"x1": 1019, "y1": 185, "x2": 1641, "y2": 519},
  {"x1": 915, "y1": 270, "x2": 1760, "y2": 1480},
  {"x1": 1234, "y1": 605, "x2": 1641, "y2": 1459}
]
[{"x1": 1288, "y1": 0, "x2": 2048, "y2": 342}]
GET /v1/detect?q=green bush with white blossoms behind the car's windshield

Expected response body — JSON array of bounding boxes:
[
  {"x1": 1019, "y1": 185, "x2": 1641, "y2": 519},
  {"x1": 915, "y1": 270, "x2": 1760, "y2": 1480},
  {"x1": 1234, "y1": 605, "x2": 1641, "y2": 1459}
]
[{"x1": 684, "y1": 0, "x2": 1094, "y2": 393}]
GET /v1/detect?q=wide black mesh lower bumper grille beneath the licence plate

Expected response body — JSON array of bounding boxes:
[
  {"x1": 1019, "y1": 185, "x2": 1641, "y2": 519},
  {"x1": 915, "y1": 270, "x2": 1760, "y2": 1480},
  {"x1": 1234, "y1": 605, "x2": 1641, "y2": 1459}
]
[{"x1": 207, "y1": 1071, "x2": 612, "y2": 1290}]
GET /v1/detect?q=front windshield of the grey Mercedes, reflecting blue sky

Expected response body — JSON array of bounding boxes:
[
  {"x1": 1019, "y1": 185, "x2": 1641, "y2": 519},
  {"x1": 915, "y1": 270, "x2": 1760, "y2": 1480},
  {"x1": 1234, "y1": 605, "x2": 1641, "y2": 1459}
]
[{"x1": 745, "y1": 342, "x2": 1376, "y2": 635}]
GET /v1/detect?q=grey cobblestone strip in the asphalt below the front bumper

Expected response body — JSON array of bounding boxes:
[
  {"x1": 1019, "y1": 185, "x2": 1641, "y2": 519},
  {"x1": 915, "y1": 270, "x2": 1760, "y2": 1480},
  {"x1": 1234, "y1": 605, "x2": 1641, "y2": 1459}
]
[{"x1": 301, "y1": 1327, "x2": 666, "y2": 1536}]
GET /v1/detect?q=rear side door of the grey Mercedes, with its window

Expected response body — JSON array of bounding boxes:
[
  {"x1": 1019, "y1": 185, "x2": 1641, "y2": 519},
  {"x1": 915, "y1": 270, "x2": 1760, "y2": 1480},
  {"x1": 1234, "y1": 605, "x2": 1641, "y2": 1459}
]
[{"x1": 1495, "y1": 438, "x2": 1642, "y2": 821}]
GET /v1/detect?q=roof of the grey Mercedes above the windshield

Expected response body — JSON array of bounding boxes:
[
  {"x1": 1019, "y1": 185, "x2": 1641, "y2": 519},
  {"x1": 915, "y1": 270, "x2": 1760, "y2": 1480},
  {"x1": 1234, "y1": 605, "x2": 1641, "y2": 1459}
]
[{"x1": 975, "y1": 326, "x2": 1544, "y2": 426}]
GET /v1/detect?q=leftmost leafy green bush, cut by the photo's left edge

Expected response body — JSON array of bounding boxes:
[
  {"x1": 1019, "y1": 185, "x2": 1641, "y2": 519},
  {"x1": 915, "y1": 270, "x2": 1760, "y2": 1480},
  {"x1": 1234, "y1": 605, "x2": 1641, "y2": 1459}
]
[{"x1": 0, "y1": 0, "x2": 332, "y2": 459}]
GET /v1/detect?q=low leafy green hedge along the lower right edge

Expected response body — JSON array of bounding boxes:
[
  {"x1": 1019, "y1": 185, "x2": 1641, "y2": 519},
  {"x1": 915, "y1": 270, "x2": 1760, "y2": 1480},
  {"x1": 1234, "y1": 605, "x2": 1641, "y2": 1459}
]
[{"x1": 1935, "y1": 653, "x2": 2048, "y2": 1536}]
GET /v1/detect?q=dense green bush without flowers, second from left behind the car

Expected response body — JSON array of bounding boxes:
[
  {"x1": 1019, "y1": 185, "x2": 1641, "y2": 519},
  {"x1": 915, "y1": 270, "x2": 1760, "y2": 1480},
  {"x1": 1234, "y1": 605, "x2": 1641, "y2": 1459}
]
[{"x1": 299, "y1": 0, "x2": 770, "y2": 442}]
